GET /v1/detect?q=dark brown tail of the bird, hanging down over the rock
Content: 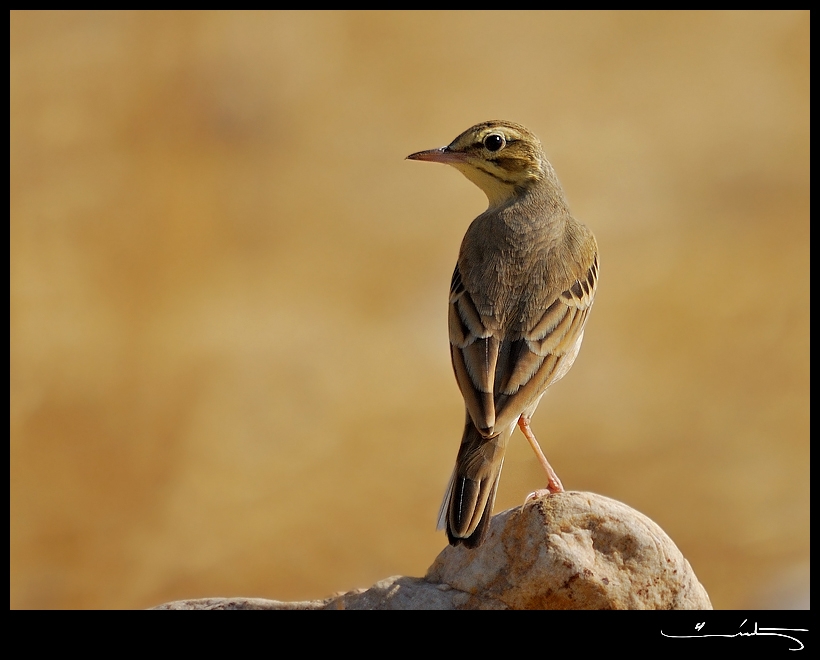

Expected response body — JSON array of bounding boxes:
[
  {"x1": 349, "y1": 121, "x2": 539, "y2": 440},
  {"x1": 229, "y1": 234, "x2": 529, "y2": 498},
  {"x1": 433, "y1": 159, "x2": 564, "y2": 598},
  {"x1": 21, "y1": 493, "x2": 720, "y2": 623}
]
[{"x1": 438, "y1": 415, "x2": 512, "y2": 548}]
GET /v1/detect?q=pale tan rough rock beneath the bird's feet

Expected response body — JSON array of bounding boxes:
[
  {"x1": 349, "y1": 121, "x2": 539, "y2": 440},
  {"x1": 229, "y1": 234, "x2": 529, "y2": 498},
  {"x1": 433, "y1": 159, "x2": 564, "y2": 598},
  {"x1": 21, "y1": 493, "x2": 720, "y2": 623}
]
[{"x1": 154, "y1": 492, "x2": 712, "y2": 610}]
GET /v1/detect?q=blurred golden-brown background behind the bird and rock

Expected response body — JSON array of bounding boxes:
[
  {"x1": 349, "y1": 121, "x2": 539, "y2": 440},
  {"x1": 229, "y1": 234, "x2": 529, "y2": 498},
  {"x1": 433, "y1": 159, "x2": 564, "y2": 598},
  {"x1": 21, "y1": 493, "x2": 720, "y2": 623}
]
[{"x1": 9, "y1": 11, "x2": 810, "y2": 609}]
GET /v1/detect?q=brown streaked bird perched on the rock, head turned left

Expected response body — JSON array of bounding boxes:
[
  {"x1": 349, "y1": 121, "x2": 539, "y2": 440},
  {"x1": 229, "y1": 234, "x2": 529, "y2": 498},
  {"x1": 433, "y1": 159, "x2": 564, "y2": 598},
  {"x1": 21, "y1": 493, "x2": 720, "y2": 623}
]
[{"x1": 407, "y1": 120, "x2": 598, "y2": 549}]
